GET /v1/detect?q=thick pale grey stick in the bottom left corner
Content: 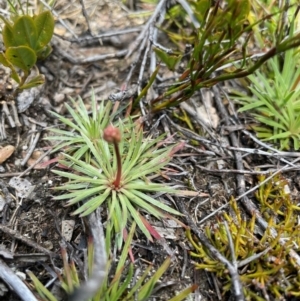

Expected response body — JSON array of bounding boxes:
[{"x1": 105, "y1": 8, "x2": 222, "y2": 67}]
[{"x1": 0, "y1": 259, "x2": 37, "y2": 301}]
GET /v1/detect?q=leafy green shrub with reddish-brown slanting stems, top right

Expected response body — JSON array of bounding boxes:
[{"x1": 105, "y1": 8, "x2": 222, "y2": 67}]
[{"x1": 138, "y1": 0, "x2": 300, "y2": 112}]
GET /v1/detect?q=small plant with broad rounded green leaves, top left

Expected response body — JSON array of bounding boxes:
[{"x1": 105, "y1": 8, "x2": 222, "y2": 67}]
[{"x1": 0, "y1": 1, "x2": 54, "y2": 91}]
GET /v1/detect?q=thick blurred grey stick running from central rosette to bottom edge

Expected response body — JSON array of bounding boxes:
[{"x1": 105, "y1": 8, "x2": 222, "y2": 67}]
[{"x1": 68, "y1": 208, "x2": 107, "y2": 301}]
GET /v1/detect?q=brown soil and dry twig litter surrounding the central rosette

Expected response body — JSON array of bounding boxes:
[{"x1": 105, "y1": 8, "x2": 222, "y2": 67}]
[{"x1": 0, "y1": 0, "x2": 300, "y2": 301}]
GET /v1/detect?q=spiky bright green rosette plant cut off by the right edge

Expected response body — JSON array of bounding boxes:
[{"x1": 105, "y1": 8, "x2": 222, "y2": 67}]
[{"x1": 236, "y1": 39, "x2": 300, "y2": 150}]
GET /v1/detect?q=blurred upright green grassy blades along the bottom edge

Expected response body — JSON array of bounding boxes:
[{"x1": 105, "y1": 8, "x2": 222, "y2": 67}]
[{"x1": 28, "y1": 224, "x2": 196, "y2": 301}]
